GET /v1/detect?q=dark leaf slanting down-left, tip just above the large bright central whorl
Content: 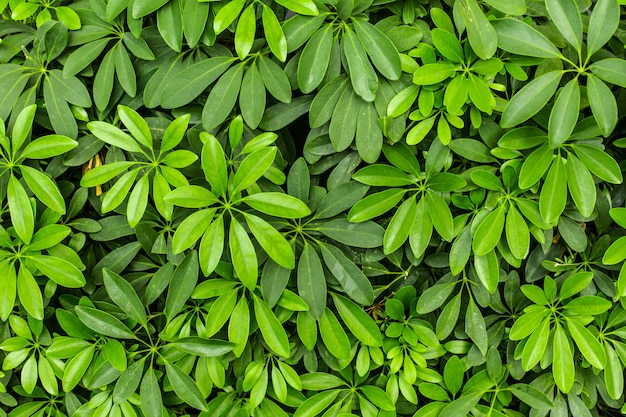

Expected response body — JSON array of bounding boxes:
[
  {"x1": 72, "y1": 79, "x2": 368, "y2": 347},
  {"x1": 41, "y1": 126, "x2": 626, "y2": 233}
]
[{"x1": 202, "y1": 63, "x2": 244, "y2": 131}]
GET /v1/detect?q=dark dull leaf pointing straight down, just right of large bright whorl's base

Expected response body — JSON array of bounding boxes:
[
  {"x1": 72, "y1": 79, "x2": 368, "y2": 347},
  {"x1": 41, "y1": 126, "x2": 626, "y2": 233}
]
[{"x1": 297, "y1": 241, "x2": 326, "y2": 320}]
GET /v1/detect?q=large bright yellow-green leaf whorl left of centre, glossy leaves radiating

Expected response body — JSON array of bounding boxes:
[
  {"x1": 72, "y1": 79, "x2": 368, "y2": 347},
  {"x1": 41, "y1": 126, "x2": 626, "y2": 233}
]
[{"x1": 165, "y1": 118, "x2": 311, "y2": 284}]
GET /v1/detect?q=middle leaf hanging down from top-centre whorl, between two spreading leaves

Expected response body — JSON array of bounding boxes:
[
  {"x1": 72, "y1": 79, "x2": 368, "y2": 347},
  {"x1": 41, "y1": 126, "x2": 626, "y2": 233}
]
[{"x1": 342, "y1": 26, "x2": 376, "y2": 102}]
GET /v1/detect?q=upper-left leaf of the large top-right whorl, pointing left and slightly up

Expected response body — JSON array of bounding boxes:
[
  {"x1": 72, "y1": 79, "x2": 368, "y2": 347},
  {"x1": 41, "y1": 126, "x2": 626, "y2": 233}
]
[{"x1": 492, "y1": 18, "x2": 560, "y2": 57}]
